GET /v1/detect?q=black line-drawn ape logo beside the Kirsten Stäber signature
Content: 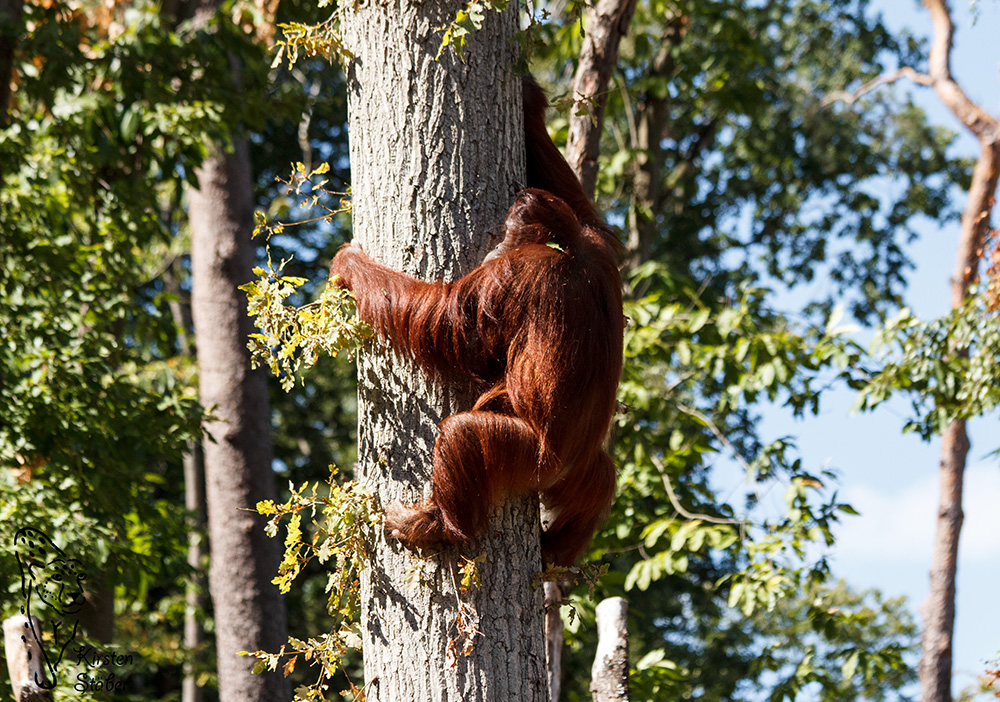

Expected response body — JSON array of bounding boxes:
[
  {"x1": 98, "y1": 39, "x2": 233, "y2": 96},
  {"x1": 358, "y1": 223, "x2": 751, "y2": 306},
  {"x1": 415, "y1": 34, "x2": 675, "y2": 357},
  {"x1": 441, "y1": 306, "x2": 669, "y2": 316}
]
[{"x1": 14, "y1": 527, "x2": 86, "y2": 689}]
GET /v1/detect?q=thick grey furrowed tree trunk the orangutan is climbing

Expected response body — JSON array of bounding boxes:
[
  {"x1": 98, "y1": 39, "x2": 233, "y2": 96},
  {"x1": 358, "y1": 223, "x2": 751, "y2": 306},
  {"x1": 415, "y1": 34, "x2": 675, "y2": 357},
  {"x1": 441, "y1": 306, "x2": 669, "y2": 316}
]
[{"x1": 342, "y1": 0, "x2": 547, "y2": 702}]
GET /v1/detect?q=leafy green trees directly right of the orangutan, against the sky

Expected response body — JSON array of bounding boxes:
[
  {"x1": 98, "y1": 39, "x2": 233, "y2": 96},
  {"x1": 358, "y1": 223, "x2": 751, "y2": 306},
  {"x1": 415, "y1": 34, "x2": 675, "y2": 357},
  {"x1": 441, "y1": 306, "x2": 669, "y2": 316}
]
[{"x1": 535, "y1": 2, "x2": 963, "y2": 699}]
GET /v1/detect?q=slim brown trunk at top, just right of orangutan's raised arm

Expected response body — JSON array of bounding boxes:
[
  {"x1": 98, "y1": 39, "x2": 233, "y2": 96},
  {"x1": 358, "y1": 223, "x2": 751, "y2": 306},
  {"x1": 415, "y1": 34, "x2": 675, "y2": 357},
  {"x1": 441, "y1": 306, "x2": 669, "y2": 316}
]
[{"x1": 566, "y1": 0, "x2": 636, "y2": 196}]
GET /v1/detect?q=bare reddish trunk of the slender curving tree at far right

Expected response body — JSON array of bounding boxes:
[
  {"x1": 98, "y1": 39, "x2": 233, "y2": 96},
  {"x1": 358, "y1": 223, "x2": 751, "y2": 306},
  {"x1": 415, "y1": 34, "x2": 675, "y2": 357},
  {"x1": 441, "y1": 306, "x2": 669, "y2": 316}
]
[{"x1": 918, "y1": 0, "x2": 1000, "y2": 702}]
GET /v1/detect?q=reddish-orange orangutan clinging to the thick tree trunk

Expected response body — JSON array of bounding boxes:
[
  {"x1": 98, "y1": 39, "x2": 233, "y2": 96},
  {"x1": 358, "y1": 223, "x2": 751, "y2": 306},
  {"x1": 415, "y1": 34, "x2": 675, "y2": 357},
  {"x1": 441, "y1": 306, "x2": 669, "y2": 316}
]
[{"x1": 330, "y1": 79, "x2": 624, "y2": 565}]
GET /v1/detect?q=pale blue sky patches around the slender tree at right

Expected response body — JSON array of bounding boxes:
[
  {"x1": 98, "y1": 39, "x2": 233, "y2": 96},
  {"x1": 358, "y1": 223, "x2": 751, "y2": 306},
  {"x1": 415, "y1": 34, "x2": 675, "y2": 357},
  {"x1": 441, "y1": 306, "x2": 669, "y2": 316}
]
[{"x1": 763, "y1": 0, "x2": 1000, "y2": 699}]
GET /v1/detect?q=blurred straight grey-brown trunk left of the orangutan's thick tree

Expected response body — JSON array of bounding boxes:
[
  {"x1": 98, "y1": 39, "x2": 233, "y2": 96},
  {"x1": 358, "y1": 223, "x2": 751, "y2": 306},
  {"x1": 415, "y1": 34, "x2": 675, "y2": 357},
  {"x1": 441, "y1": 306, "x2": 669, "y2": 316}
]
[{"x1": 189, "y1": 140, "x2": 290, "y2": 702}]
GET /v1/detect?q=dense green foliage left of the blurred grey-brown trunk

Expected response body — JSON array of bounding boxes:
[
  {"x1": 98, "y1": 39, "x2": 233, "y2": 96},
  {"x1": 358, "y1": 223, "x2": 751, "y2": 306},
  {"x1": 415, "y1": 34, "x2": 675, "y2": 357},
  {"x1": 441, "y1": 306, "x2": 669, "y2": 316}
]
[{"x1": 0, "y1": 4, "x2": 216, "y2": 695}]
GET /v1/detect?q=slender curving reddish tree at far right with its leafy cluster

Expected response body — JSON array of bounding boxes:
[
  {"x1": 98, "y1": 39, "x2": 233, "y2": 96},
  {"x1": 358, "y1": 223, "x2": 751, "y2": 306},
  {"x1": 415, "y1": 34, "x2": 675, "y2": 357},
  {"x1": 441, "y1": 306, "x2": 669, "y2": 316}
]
[{"x1": 832, "y1": 0, "x2": 1000, "y2": 702}]
